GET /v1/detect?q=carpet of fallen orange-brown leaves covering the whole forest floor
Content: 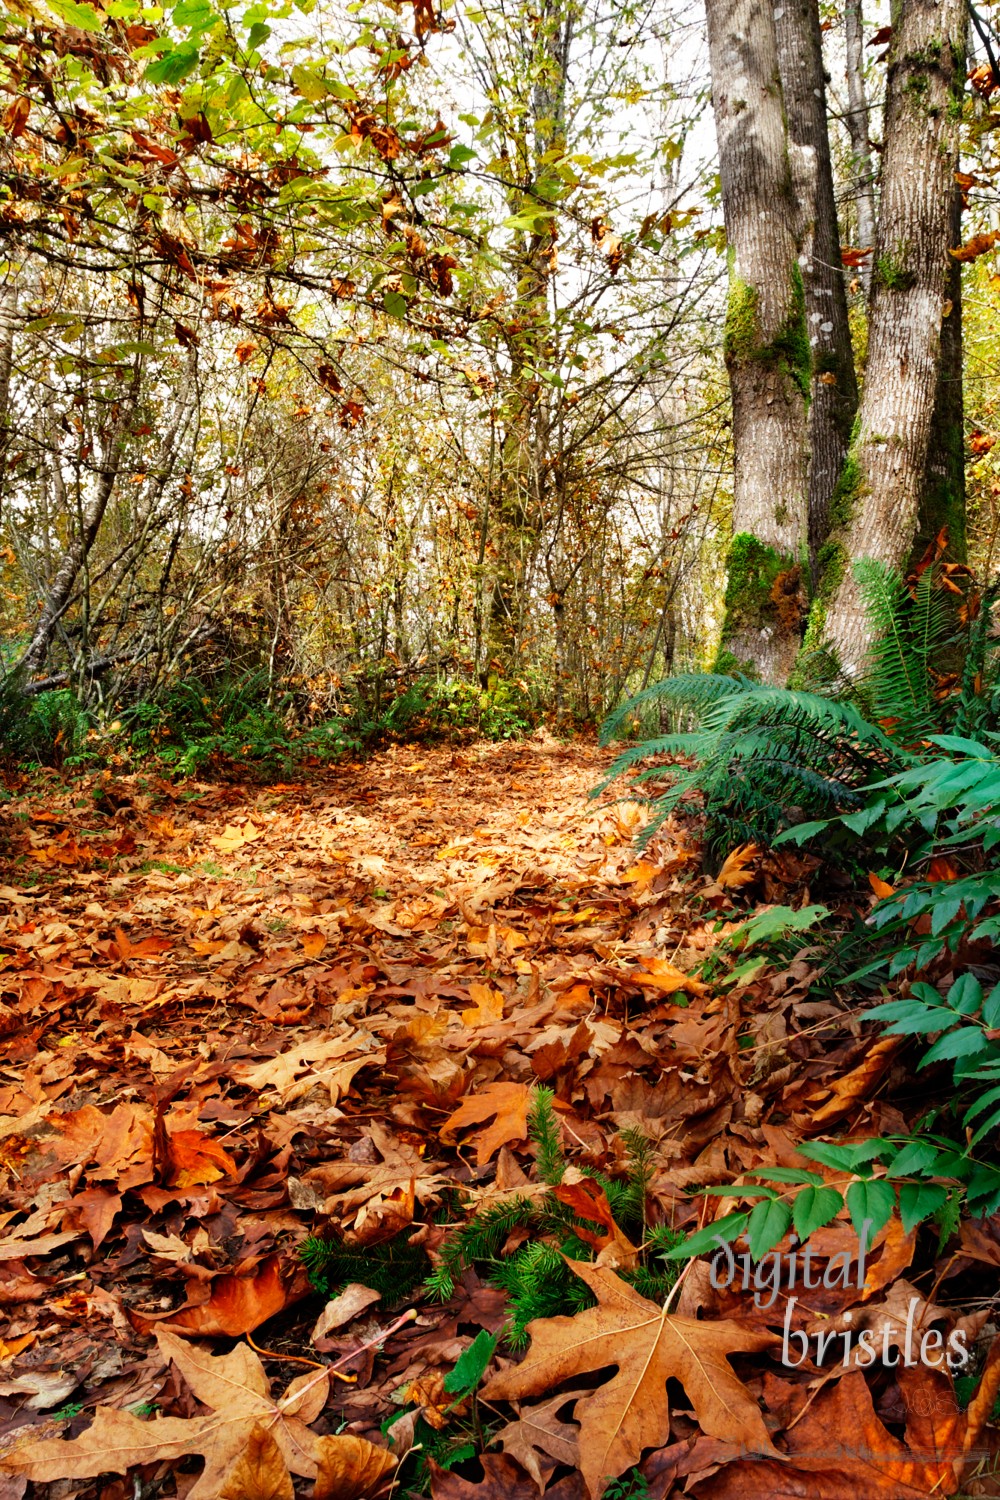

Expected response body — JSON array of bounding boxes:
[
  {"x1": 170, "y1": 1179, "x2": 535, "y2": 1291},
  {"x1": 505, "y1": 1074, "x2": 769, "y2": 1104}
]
[{"x1": 0, "y1": 735, "x2": 1000, "y2": 1500}]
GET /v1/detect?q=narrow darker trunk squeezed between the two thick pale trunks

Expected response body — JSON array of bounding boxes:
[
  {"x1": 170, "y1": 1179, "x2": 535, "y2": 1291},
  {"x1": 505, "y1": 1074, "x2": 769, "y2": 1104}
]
[{"x1": 774, "y1": 0, "x2": 858, "y2": 557}]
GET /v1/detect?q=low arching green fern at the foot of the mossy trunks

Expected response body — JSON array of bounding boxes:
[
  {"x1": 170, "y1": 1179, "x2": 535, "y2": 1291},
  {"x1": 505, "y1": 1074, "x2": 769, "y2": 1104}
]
[{"x1": 594, "y1": 674, "x2": 901, "y2": 849}]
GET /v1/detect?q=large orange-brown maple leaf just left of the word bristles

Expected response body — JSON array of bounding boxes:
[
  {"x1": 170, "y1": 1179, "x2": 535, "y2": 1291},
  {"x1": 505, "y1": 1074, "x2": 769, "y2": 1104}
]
[{"x1": 483, "y1": 1260, "x2": 777, "y2": 1497}]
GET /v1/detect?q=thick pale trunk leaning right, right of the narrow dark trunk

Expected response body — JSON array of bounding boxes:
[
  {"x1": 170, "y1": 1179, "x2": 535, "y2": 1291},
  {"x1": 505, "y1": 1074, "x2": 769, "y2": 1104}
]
[{"x1": 807, "y1": 0, "x2": 966, "y2": 680}]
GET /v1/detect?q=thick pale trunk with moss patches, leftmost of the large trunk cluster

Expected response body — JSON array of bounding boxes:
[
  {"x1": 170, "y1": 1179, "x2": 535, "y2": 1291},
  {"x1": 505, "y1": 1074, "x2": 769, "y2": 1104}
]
[{"x1": 708, "y1": 0, "x2": 813, "y2": 683}]
